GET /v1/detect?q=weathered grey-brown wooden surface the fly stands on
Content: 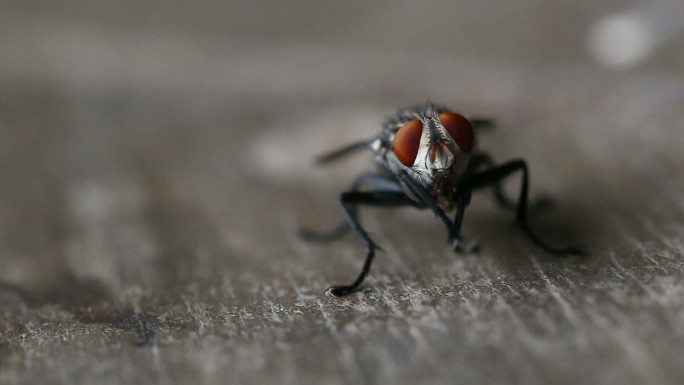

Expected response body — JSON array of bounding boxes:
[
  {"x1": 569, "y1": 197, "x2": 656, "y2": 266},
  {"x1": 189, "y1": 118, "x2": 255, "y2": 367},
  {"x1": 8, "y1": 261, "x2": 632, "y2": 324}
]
[{"x1": 0, "y1": 1, "x2": 684, "y2": 385}]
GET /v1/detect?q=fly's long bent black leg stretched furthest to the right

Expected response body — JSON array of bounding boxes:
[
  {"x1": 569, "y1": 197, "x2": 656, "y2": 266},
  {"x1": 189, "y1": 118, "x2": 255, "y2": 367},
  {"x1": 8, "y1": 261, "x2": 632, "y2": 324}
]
[{"x1": 460, "y1": 160, "x2": 585, "y2": 255}]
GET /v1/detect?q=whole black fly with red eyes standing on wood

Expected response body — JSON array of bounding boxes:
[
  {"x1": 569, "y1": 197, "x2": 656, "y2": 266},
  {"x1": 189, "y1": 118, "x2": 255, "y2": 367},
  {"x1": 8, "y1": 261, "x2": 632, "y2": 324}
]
[{"x1": 302, "y1": 102, "x2": 584, "y2": 297}]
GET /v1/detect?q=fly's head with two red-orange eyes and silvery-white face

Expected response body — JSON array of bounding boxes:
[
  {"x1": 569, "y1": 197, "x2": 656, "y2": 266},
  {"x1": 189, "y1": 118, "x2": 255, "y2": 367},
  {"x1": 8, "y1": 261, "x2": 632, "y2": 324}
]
[{"x1": 392, "y1": 108, "x2": 475, "y2": 206}]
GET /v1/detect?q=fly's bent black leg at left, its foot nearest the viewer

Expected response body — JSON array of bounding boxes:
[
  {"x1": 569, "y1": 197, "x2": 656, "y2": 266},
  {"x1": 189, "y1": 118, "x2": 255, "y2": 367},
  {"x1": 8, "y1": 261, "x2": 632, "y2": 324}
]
[{"x1": 326, "y1": 191, "x2": 415, "y2": 297}]
